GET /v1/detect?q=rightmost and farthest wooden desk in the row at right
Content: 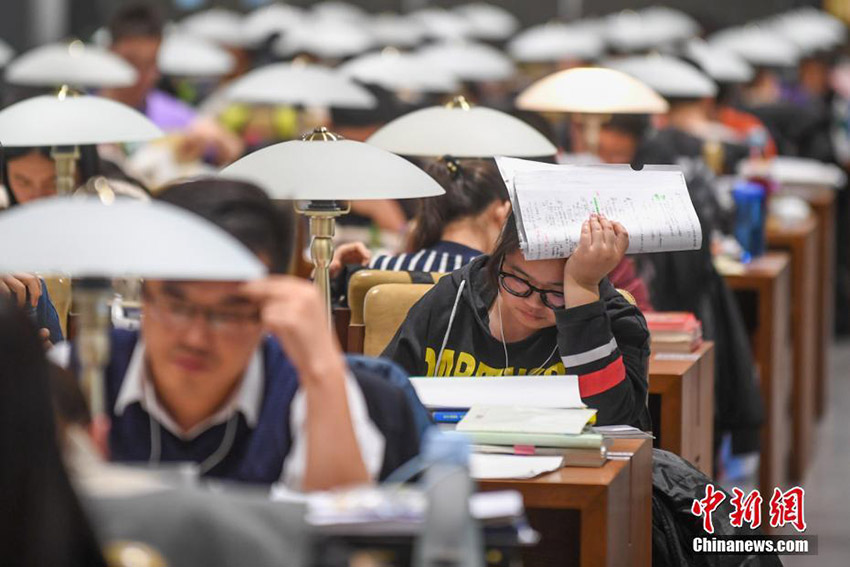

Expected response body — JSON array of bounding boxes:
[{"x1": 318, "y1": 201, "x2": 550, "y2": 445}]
[{"x1": 780, "y1": 185, "x2": 837, "y2": 418}]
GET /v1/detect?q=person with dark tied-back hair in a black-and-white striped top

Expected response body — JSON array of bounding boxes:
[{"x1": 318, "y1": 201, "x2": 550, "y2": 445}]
[{"x1": 369, "y1": 157, "x2": 511, "y2": 272}]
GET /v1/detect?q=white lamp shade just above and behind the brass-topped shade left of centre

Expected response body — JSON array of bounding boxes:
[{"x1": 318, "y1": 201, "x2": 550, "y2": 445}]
[{"x1": 225, "y1": 63, "x2": 378, "y2": 109}]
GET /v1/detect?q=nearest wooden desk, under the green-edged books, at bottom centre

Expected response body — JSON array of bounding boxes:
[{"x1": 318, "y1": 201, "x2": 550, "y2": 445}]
[{"x1": 479, "y1": 439, "x2": 652, "y2": 567}]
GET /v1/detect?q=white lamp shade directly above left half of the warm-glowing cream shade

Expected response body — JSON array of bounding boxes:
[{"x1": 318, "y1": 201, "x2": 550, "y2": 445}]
[{"x1": 508, "y1": 22, "x2": 605, "y2": 63}]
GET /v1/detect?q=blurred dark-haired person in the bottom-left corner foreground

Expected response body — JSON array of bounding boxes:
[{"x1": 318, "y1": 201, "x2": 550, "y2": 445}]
[{"x1": 0, "y1": 297, "x2": 105, "y2": 567}]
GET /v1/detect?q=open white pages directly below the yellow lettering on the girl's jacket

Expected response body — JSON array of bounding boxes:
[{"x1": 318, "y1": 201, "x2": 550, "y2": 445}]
[{"x1": 410, "y1": 376, "x2": 587, "y2": 409}]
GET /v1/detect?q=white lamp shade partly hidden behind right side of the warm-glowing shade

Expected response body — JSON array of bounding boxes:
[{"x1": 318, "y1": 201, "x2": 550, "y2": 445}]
[{"x1": 603, "y1": 55, "x2": 717, "y2": 99}]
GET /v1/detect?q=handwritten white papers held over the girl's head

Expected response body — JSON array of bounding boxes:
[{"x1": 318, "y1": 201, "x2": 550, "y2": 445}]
[{"x1": 514, "y1": 166, "x2": 702, "y2": 260}]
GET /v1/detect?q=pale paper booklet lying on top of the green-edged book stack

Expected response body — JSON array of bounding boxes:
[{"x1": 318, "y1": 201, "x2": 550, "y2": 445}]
[{"x1": 457, "y1": 406, "x2": 596, "y2": 435}]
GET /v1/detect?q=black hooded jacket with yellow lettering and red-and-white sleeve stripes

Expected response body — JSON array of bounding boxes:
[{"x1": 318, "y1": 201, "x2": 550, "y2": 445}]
[{"x1": 382, "y1": 256, "x2": 650, "y2": 430}]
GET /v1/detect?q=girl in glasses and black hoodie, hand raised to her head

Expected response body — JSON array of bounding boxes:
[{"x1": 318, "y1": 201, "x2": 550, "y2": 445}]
[{"x1": 383, "y1": 214, "x2": 650, "y2": 429}]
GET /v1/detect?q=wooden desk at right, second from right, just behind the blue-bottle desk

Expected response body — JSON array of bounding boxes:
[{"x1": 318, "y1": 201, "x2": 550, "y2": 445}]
[{"x1": 767, "y1": 216, "x2": 820, "y2": 482}]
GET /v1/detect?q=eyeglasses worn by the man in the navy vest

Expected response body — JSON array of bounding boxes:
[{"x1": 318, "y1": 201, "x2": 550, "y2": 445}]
[{"x1": 145, "y1": 293, "x2": 260, "y2": 336}]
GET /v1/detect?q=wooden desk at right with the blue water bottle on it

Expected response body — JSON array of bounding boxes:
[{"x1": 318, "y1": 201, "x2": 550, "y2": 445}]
[{"x1": 725, "y1": 252, "x2": 793, "y2": 516}]
